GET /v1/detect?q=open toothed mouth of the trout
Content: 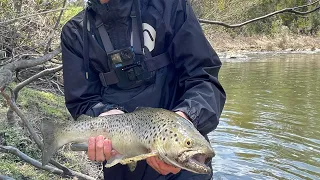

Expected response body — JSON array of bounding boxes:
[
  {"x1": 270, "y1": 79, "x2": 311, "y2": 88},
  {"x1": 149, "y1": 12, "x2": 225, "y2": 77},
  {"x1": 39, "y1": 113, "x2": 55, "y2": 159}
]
[{"x1": 178, "y1": 151, "x2": 214, "y2": 174}]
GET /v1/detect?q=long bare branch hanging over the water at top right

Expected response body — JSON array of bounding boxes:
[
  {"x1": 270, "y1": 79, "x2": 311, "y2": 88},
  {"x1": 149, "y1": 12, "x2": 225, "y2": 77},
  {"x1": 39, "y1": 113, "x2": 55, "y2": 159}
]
[{"x1": 199, "y1": 0, "x2": 320, "y2": 28}]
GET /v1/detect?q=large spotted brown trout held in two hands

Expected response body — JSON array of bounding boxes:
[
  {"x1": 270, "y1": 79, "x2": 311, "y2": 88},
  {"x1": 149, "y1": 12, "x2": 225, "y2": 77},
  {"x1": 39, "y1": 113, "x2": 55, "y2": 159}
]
[{"x1": 41, "y1": 108, "x2": 215, "y2": 174}]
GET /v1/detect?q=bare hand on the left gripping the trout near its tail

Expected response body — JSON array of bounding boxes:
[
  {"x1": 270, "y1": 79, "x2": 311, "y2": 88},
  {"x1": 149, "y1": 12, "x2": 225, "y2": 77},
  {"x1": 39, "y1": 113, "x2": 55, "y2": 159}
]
[{"x1": 88, "y1": 109, "x2": 124, "y2": 162}]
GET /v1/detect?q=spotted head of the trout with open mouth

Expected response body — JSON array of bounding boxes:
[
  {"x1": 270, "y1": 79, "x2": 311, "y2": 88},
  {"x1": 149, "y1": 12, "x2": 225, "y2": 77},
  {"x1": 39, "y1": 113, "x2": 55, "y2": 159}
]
[{"x1": 157, "y1": 113, "x2": 215, "y2": 174}]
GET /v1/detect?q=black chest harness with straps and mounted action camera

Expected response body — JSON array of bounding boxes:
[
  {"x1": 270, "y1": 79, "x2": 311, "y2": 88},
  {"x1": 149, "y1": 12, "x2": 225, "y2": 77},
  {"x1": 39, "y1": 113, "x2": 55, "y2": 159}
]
[{"x1": 84, "y1": 0, "x2": 171, "y2": 89}]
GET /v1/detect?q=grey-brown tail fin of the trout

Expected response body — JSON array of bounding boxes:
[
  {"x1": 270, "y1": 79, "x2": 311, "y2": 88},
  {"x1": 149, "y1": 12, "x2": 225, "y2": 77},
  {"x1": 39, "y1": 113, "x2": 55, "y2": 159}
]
[{"x1": 41, "y1": 120, "x2": 62, "y2": 166}]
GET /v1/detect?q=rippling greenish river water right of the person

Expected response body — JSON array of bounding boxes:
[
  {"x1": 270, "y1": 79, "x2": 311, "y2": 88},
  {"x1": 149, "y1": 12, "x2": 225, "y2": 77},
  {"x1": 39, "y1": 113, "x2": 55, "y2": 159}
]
[{"x1": 210, "y1": 54, "x2": 320, "y2": 179}]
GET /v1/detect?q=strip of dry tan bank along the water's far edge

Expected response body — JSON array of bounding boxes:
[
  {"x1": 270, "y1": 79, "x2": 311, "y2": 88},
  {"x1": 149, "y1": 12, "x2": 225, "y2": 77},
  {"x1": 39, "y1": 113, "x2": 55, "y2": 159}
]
[{"x1": 206, "y1": 33, "x2": 320, "y2": 58}]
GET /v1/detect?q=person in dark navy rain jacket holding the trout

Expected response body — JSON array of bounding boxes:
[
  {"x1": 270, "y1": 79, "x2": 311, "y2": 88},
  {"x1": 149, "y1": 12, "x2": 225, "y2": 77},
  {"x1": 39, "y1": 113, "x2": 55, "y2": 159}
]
[{"x1": 61, "y1": 0, "x2": 226, "y2": 180}]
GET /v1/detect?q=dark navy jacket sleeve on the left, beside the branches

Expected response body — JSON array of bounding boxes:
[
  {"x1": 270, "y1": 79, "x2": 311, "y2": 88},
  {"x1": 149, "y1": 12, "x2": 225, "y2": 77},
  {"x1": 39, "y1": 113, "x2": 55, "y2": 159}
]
[{"x1": 61, "y1": 23, "x2": 124, "y2": 119}]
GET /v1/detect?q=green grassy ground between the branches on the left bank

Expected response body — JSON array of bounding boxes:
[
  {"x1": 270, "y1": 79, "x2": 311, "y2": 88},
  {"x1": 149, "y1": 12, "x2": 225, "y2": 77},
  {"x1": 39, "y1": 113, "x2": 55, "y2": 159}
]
[{"x1": 0, "y1": 85, "x2": 90, "y2": 180}]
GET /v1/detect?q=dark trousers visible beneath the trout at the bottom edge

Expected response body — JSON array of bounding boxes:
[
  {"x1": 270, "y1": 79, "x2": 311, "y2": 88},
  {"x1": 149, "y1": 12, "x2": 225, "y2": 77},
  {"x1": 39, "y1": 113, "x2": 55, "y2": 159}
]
[{"x1": 103, "y1": 161, "x2": 212, "y2": 180}]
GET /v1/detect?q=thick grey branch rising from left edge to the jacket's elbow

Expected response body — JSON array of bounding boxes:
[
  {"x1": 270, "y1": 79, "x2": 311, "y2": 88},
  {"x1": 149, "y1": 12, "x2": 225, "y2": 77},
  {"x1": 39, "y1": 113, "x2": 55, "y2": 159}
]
[{"x1": 0, "y1": 47, "x2": 61, "y2": 88}]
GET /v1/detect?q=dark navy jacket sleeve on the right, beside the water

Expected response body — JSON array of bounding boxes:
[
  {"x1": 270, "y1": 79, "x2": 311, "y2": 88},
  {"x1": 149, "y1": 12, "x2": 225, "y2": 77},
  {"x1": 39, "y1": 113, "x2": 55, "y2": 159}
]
[{"x1": 169, "y1": 0, "x2": 226, "y2": 134}]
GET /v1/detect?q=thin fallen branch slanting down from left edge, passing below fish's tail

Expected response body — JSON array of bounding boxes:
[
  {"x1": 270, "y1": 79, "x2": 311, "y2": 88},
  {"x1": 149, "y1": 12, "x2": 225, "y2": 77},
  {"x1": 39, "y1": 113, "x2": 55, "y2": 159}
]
[{"x1": 1, "y1": 88, "x2": 93, "y2": 179}]
